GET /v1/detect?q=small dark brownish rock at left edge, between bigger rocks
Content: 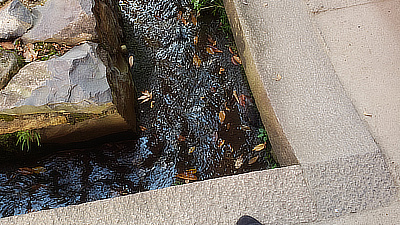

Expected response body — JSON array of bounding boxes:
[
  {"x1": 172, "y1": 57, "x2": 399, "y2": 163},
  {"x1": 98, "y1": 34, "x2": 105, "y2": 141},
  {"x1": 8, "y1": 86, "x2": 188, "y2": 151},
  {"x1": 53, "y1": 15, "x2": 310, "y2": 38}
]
[{"x1": 0, "y1": 49, "x2": 18, "y2": 90}]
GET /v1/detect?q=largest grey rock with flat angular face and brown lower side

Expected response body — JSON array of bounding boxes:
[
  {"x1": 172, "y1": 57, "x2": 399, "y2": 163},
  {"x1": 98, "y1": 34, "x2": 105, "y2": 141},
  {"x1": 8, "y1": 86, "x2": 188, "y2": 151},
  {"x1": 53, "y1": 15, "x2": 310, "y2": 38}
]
[{"x1": 0, "y1": 43, "x2": 134, "y2": 143}]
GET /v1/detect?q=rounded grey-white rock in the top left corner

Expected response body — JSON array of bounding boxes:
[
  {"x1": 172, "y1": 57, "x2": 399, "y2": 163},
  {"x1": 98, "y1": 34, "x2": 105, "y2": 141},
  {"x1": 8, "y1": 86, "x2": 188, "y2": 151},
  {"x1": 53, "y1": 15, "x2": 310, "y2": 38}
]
[{"x1": 0, "y1": 0, "x2": 33, "y2": 39}]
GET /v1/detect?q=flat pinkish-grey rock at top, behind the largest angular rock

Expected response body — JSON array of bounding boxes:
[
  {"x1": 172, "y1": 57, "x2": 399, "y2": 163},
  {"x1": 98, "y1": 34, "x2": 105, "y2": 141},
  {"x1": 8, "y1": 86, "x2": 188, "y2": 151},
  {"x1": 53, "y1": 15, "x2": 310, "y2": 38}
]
[{"x1": 22, "y1": 0, "x2": 97, "y2": 45}]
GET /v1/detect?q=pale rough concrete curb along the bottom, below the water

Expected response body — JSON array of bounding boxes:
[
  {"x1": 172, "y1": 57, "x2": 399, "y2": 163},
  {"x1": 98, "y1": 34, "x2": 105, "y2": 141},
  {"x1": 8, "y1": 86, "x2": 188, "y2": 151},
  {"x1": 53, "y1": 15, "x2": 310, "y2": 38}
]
[{"x1": 0, "y1": 166, "x2": 317, "y2": 225}]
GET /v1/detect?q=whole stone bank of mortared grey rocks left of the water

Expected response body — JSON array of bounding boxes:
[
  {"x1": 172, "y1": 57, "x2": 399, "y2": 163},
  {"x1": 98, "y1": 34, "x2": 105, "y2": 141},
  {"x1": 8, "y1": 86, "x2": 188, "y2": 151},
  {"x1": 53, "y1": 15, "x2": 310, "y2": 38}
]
[{"x1": 0, "y1": 0, "x2": 137, "y2": 143}]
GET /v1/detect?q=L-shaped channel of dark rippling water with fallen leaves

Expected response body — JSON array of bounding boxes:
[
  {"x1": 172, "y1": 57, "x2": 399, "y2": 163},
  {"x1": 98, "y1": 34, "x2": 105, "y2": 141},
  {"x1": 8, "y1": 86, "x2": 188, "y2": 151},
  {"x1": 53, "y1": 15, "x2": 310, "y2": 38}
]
[{"x1": 0, "y1": 0, "x2": 275, "y2": 217}]
